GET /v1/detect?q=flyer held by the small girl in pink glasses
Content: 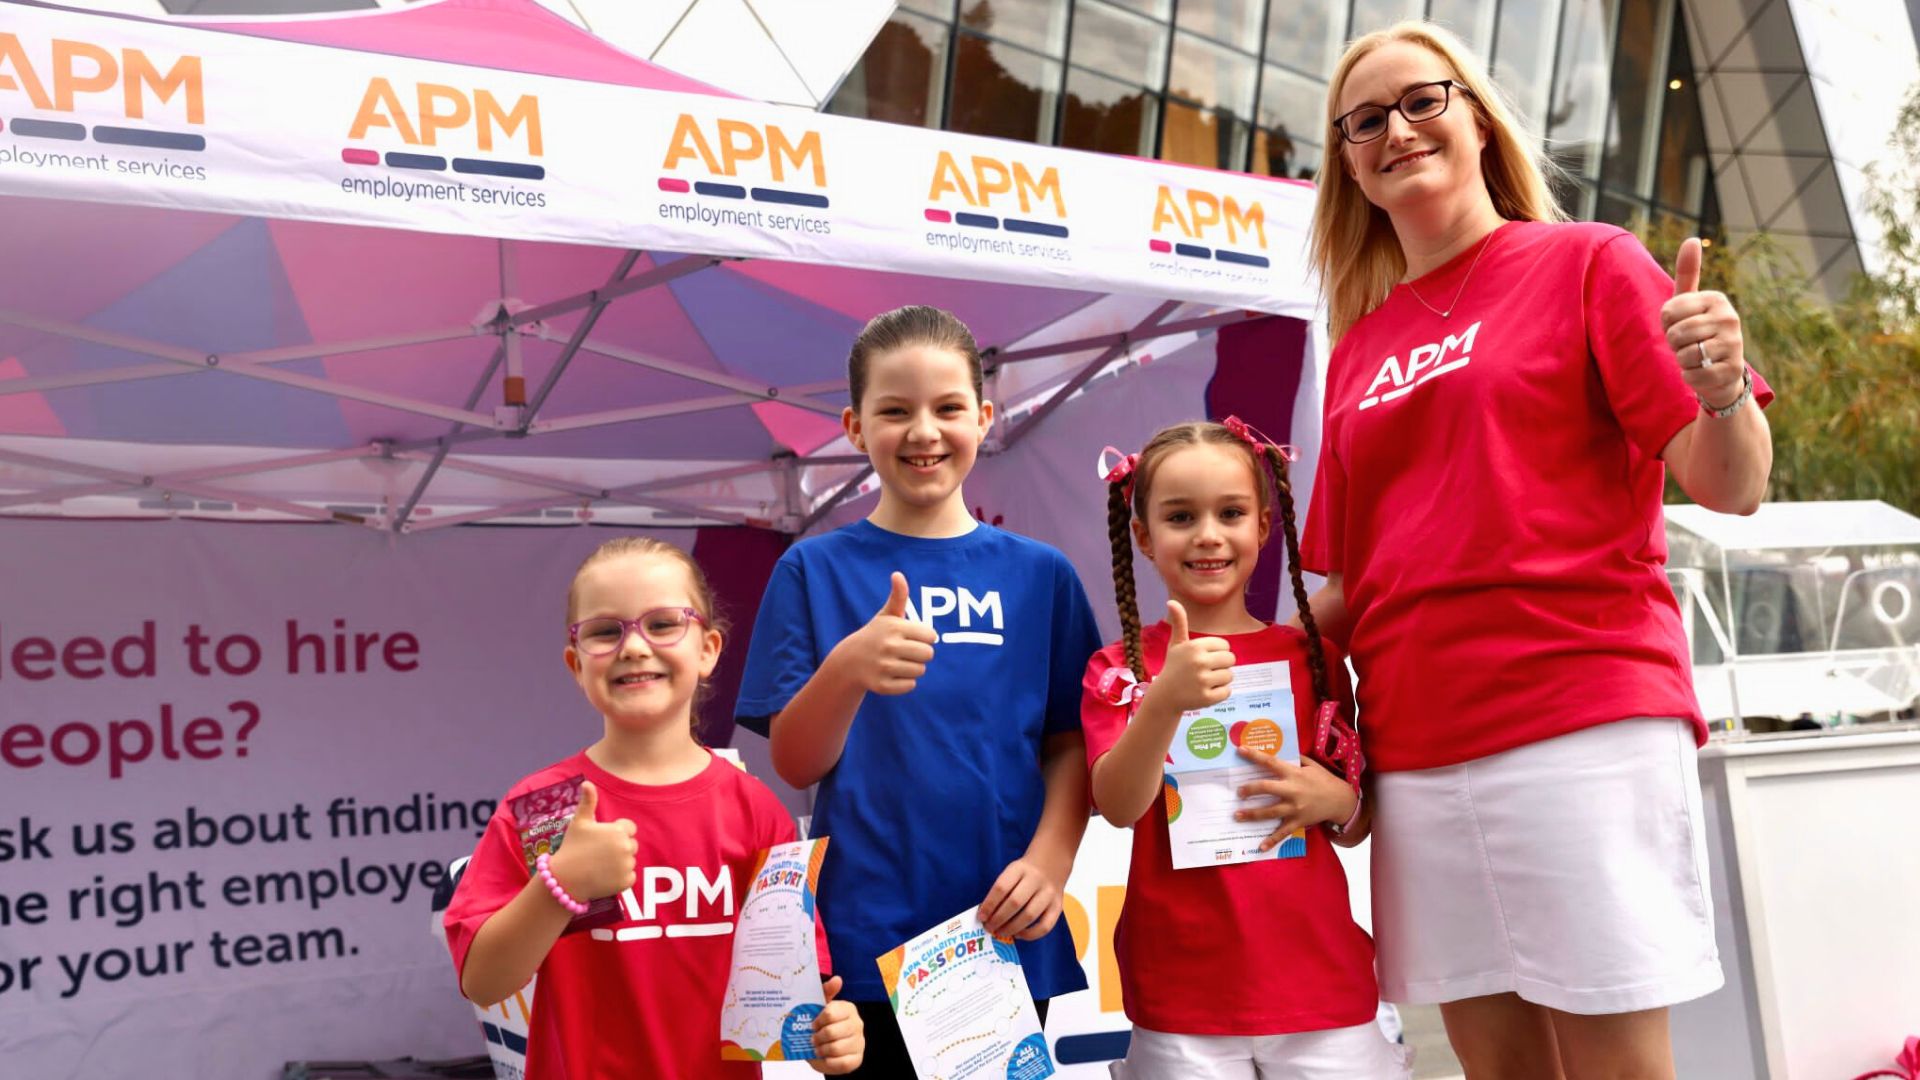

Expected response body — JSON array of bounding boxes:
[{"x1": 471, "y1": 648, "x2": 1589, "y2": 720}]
[{"x1": 720, "y1": 836, "x2": 828, "y2": 1061}]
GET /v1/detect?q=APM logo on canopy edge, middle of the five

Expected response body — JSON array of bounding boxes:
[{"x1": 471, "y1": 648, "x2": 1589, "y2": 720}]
[{"x1": 660, "y1": 113, "x2": 828, "y2": 209}]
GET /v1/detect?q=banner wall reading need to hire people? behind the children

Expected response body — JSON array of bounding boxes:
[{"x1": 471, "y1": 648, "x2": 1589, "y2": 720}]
[{"x1": 0, "y1": 521, "x2": 693, "y2": 1076}]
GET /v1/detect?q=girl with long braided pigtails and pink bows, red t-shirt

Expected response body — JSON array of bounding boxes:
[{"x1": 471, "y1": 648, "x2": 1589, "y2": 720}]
[{"x1": 1081, "y1": 417, "x2": 1409, "y2": 1080}]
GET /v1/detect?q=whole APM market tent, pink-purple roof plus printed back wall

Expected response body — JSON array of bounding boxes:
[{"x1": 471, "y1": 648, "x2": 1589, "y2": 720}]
[{"x1": 0, "y1": 0, "x2": 1317, "y2": 1074}]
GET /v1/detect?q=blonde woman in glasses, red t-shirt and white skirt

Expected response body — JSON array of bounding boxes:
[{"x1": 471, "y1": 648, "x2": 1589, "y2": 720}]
[{"x1": 1304, "y1": 23, "x2": 1772, "y2": 1080}]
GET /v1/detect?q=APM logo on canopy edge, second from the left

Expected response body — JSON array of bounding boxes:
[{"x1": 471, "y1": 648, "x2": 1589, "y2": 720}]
[{"x1": 340, "y1": 77, "x2": 547, "y2": 181}]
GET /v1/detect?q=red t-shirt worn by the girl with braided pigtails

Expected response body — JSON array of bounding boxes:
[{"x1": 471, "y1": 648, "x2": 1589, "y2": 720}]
[{"x1": 1081, "y1": 623, "x2": 1380, "y2": 1036}]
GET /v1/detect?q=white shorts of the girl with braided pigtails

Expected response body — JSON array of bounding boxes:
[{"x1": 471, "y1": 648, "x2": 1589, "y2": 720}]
[{"x1": 1108, "y1": 1020, "x2": 1413, "y2": 1080}]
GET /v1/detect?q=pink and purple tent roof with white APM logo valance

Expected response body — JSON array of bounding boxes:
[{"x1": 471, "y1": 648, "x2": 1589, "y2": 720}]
[{"x1": 0, "y1": 0, "x2": 1315, "y2": 532}]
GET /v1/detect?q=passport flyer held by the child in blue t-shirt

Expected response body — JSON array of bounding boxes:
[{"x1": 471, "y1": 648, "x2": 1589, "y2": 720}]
[{"x1": 879, "y1": 909, "x2": 1054, "y2": 1080}]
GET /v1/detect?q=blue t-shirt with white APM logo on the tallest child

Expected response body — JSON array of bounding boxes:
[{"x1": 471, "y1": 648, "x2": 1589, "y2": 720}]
[{"x1": 735, "y1": 521, "x2": 1100, "y2": 1001}]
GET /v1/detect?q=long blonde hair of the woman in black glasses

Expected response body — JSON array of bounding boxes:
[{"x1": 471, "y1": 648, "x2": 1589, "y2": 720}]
[{"x1": 1309, "y1": 19, "x2": 1567, "y2": 340}]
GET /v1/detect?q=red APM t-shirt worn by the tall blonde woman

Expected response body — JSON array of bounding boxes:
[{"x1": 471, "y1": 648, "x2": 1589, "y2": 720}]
[{"x1": 1302, "y1": 221, "x2": 1772, "y2": 771}]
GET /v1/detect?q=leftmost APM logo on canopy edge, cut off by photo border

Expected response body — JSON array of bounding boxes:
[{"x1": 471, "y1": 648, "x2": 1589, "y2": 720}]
[{"x1": 0, "y1": 33, "x2": 207, "y2": 150}]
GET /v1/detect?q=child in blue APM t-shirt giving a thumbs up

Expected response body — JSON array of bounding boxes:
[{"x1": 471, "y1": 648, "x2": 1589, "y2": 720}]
[{"x1": 735, "y1": 306, "x2": 1100, "y2": 1076}]
